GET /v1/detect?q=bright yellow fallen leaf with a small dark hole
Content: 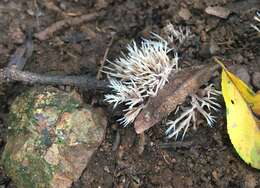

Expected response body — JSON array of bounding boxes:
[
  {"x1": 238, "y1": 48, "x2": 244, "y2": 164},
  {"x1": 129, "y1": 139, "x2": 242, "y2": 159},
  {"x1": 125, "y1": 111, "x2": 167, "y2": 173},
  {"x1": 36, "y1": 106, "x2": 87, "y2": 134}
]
[{"x1": 216, "y1": 58, "x2": 260, "y2": 169}]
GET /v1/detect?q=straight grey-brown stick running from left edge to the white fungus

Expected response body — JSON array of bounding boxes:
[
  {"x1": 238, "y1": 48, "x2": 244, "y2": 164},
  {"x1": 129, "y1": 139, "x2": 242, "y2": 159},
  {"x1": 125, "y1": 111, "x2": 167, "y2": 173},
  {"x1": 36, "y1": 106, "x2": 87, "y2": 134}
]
[{"x1": 0, "y1": 68, "x2": 109, "y2": 92}]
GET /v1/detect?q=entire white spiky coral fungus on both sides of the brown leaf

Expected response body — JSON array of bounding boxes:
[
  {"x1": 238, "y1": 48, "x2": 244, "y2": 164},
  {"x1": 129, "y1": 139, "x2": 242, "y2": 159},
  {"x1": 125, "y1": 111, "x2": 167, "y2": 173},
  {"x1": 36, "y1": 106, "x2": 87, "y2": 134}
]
[{"x1": 103, "y1": 25, "x2": 219, "y2": 139}]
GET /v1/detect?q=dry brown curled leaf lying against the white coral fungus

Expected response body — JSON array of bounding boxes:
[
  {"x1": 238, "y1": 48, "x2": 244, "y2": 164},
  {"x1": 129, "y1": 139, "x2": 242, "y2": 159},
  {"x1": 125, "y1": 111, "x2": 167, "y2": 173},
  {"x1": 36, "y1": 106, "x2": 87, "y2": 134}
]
[{"x1": 134, "y1": 65, "x2": 219, "y2": 134}]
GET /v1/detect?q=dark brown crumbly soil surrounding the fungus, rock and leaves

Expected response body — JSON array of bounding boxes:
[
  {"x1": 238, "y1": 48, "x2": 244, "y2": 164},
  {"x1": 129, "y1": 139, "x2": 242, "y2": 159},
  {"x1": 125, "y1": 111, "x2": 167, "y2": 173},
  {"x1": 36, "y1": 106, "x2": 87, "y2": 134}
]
[{"x1": 0, "y1": 0, "x2": 260, "y2": 188}]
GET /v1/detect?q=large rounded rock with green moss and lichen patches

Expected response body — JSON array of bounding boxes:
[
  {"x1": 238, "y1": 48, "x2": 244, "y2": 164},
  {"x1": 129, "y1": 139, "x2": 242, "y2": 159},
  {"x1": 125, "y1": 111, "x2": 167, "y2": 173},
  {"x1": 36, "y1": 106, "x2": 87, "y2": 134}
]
[{"x1": 2, "y1": 87, "x2": 106, "y2": 188}]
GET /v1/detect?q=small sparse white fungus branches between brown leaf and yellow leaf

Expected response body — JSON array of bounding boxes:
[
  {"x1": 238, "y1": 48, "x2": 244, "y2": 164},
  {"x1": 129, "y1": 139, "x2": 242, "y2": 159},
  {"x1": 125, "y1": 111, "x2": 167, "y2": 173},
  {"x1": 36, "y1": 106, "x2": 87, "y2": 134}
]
[{"x1": 165, "y1": 84, "x2": 221, "y2": 140}]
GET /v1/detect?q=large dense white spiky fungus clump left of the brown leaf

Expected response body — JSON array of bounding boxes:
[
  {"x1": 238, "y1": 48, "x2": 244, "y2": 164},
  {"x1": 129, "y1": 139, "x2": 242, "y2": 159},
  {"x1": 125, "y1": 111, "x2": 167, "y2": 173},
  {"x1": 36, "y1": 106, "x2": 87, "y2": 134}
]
[{"x1": 103, "y1": 38, "x2": 178, "y2": 126}]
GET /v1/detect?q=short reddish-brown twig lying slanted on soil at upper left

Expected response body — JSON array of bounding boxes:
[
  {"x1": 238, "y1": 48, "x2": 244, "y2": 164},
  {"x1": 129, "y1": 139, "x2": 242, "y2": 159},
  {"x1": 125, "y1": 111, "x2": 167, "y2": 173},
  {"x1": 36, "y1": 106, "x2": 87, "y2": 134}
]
[{"x1": 34, "y1": 12, "x2": 98, "y2": 41}]
